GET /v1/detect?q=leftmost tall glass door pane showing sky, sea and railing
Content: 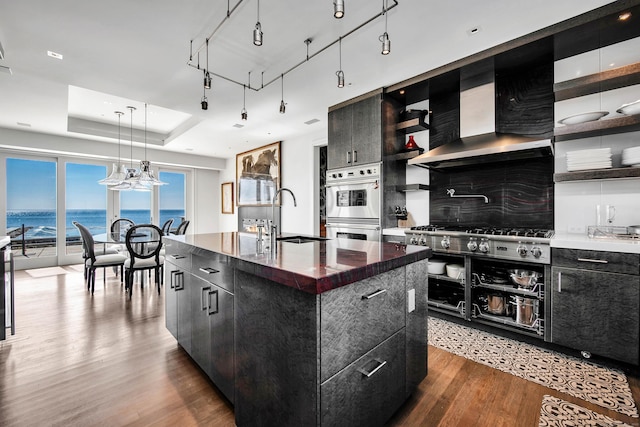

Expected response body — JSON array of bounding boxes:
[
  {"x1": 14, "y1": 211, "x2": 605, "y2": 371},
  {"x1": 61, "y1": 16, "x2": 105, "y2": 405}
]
[{"x1": 6, "y1": 158, "x2": 57, "y2": 257}]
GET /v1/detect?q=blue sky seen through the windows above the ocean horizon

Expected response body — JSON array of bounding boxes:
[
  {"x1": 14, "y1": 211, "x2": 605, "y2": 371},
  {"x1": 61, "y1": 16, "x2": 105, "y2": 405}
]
[{"x1": 6, "y1": 159, "x2": 185, "y2": 210}]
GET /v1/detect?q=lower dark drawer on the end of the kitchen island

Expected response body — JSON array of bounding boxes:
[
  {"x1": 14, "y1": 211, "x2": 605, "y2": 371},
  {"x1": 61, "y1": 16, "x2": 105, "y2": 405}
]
[{"x1": 320, "y1": 329, "x2": 405, "y2": 427}]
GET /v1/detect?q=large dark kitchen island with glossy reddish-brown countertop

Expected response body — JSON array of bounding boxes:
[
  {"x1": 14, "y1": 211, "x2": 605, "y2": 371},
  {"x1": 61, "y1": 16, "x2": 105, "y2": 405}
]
[{"x1": 165, "y1": 233, "x2": 431, "y2": 426}]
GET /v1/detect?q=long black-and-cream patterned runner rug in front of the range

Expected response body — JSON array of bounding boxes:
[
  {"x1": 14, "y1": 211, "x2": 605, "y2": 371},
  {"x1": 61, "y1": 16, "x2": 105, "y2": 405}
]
[{"x1": 429, "y1": 317, "x2": 638, "y2": 418}]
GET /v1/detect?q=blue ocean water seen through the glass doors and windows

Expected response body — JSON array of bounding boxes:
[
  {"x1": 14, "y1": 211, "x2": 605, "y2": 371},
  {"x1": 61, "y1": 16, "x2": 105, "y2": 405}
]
[{"x1": 7, "y1": 209, "x2": 185, "y2": 239}]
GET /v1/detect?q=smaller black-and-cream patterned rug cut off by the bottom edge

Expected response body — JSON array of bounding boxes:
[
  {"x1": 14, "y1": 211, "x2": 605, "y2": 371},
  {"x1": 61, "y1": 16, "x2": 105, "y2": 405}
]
[{"x1": 538, "y1": 395, "x2": 632, "y2": 427}]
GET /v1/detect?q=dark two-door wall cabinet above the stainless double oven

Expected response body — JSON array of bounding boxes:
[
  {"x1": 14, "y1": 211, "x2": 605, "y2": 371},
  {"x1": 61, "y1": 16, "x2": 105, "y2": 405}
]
[{"x1": 327, "y1": 94, "x2": 382, "y2": 169}]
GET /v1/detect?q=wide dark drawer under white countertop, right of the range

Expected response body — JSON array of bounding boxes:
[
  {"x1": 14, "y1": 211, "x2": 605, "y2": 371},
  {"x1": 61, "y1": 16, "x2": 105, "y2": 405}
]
[{"x1": 551, "y1": 248, "x2": 640, "y2": 275}]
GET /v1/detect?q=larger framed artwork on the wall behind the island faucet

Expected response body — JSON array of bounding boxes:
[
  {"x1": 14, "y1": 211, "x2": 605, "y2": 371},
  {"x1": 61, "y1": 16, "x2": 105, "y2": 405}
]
[{"x1": 236, "y1": 141, "x2": 280, "y2": 206}]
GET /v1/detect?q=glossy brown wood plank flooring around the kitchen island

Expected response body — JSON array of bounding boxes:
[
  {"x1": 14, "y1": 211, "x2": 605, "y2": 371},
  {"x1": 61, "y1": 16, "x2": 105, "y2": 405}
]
[{"x1": 0, "y1": 266, "x2": 640, "y2": 427}]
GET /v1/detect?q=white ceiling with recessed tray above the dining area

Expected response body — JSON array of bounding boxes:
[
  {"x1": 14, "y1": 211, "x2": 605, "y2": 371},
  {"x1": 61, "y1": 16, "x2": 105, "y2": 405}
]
[{"x1": 0, "y1": 0, "x2": 611, "y2": 158}]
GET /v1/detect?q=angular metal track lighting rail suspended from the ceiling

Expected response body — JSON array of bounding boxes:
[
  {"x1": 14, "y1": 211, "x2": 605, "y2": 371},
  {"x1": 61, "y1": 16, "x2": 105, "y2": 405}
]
[{"x1": 187, "y1": 0, "x2": 398, "y2": 92}]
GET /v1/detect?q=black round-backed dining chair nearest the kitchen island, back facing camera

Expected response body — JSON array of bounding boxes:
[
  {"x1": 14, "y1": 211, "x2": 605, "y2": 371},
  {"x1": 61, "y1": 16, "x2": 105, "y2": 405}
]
[{"x1": 124, "y1": 224, "x2": 164, "y2": 299}]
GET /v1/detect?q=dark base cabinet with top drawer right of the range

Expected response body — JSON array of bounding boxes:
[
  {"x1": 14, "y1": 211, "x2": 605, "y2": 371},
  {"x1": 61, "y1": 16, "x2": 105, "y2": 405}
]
[{"x1": 551, "y1": 248, "x2": 640, "y2": 365}]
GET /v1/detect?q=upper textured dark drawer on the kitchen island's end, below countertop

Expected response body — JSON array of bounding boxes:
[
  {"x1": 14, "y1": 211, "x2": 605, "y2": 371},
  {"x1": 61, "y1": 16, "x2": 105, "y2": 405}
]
[{"x1": 320, "y1": 268, "x2": 406, "y2": 381}]
